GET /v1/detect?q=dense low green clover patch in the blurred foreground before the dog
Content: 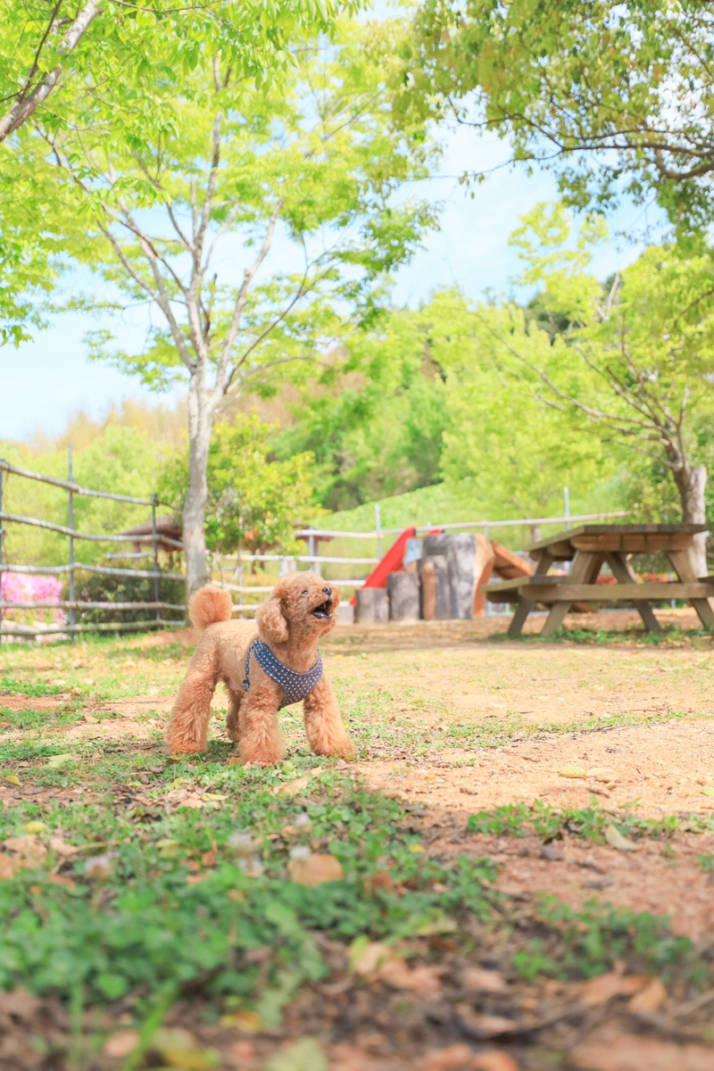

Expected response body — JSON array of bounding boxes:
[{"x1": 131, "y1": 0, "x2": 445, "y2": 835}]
[{"x1": 0, "y1": 764, "x2": 495, "y2": 1005}]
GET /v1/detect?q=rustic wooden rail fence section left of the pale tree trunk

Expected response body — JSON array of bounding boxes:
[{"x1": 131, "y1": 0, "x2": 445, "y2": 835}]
[{"x1": 0, "y1": 456, "x2": 185, "y2": 637}]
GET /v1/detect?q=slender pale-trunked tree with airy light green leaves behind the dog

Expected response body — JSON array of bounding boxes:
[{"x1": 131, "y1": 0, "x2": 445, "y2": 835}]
[{"x1": 16, "y1": 14, "x2": 434, "y2": 587}]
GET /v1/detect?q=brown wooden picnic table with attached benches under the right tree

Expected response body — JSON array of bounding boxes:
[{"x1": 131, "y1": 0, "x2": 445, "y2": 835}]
[{"x1": 486, "y1": 524, "x2": 714, "y2": 636}]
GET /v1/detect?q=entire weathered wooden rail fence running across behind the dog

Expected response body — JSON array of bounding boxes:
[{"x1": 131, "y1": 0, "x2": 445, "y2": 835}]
[{"x1": 0, "y1": 448, "x2": 626, "y2": 638}]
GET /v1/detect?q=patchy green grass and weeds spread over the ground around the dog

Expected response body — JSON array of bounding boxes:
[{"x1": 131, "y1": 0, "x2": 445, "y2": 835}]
[{"x1": 0, "y1": 637, "x2": 714, "y2": 1071}]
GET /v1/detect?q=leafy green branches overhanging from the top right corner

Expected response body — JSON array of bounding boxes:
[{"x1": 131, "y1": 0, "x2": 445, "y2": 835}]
[{"x1": 400, "y1": 0, "x2": 714, "y2": 232}]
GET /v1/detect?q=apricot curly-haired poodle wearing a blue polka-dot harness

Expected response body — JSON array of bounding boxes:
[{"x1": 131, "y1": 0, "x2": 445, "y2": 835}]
[{"x1": 168, "y1": 573, "x2": 354, "y2": 766}]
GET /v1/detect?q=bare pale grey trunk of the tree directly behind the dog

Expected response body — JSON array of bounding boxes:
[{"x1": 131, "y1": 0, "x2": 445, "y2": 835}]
[{"x1": 183, "y1": 376, "x2": 213, "y2": 595}]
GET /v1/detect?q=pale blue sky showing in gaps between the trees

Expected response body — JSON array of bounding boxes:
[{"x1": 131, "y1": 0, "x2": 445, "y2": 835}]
[{"x1": 0, "y1": 118, "x2": 648, "y2": 440}]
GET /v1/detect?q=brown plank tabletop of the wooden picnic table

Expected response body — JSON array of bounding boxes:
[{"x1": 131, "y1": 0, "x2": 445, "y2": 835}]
[{"x1": 528, "y1": 524, "x2": 707, "y2": 561}]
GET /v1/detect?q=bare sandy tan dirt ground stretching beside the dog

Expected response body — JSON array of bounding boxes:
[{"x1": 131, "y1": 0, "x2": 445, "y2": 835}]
[{"x1": 0, "y1": 610, "x2": 714, "y2": 1071}]
